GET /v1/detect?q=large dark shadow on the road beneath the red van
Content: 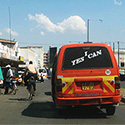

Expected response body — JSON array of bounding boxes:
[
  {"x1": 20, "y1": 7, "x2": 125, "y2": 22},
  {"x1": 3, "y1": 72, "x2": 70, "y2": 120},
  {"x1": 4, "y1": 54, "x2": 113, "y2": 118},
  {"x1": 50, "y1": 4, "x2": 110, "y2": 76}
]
[{"x1": 22, "y1": 102, "x2": 107, "y2": 119}]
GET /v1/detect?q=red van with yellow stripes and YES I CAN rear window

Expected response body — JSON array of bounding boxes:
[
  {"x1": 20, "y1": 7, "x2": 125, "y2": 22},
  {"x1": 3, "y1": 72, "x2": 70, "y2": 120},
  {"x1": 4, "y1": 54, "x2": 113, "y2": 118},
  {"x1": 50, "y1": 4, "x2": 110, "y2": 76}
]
[{"x1": 51, "y1": 43, "x2": 121, "y2": 115}]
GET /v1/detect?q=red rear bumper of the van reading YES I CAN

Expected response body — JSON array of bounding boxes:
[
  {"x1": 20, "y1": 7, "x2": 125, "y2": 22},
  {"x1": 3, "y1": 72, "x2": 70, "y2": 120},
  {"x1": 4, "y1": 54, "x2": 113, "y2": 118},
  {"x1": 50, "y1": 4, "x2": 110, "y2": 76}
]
[{"x1": 57, "y1": 95, "x2": 121, "y2": 106}]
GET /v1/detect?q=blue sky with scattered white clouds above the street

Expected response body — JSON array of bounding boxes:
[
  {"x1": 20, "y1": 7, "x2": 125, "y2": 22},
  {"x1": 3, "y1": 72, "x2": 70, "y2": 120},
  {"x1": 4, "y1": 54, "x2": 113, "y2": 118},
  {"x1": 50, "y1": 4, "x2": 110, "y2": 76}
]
[{"x1": 0, "y1": 0, "x2": 125, "y2": 51}]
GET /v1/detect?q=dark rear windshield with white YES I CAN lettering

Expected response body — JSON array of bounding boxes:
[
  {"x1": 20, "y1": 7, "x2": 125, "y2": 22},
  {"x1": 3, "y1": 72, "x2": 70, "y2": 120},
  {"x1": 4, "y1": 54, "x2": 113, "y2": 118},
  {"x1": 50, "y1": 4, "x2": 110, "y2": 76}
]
[{"x1": 62, "y1": 47, "x2": 113, "y2": 70}]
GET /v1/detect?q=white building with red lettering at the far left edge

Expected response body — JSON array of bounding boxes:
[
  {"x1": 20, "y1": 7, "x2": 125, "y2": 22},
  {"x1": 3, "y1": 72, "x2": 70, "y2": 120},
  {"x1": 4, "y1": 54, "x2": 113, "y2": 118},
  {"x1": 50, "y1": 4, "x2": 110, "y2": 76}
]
[{"x1": 0, "y1": 39, "x2": 24, "y2": 67}]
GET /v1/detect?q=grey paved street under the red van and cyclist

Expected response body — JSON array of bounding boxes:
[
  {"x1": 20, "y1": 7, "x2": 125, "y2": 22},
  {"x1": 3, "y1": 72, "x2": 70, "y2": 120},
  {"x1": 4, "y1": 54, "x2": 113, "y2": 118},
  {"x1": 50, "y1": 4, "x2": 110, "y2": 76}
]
[{"x1": 0, "y1": 80, "x2": 125, "y2": 124}]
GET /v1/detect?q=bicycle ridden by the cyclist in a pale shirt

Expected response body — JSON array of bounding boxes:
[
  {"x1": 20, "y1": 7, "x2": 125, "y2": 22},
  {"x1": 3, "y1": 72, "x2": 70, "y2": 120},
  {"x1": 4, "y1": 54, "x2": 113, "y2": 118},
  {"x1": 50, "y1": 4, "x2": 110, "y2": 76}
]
[{"x1": 27, "y1": 76, "x2": 36, "y2": 100}]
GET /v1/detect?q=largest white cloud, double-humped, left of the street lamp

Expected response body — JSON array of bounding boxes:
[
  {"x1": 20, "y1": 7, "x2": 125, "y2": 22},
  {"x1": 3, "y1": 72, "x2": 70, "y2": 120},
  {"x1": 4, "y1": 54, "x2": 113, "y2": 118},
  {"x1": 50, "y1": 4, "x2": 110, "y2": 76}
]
[{"x1": 28, "y1": 14, "x2": 86, "y2": 33}]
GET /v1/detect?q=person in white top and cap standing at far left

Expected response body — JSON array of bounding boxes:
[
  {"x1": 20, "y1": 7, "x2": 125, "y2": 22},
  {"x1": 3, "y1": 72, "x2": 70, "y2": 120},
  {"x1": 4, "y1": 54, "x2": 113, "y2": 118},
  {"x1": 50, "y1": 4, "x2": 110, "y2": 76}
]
[{"x1": 4, "y1": 65, "x2": 13, "y2": 94}]
